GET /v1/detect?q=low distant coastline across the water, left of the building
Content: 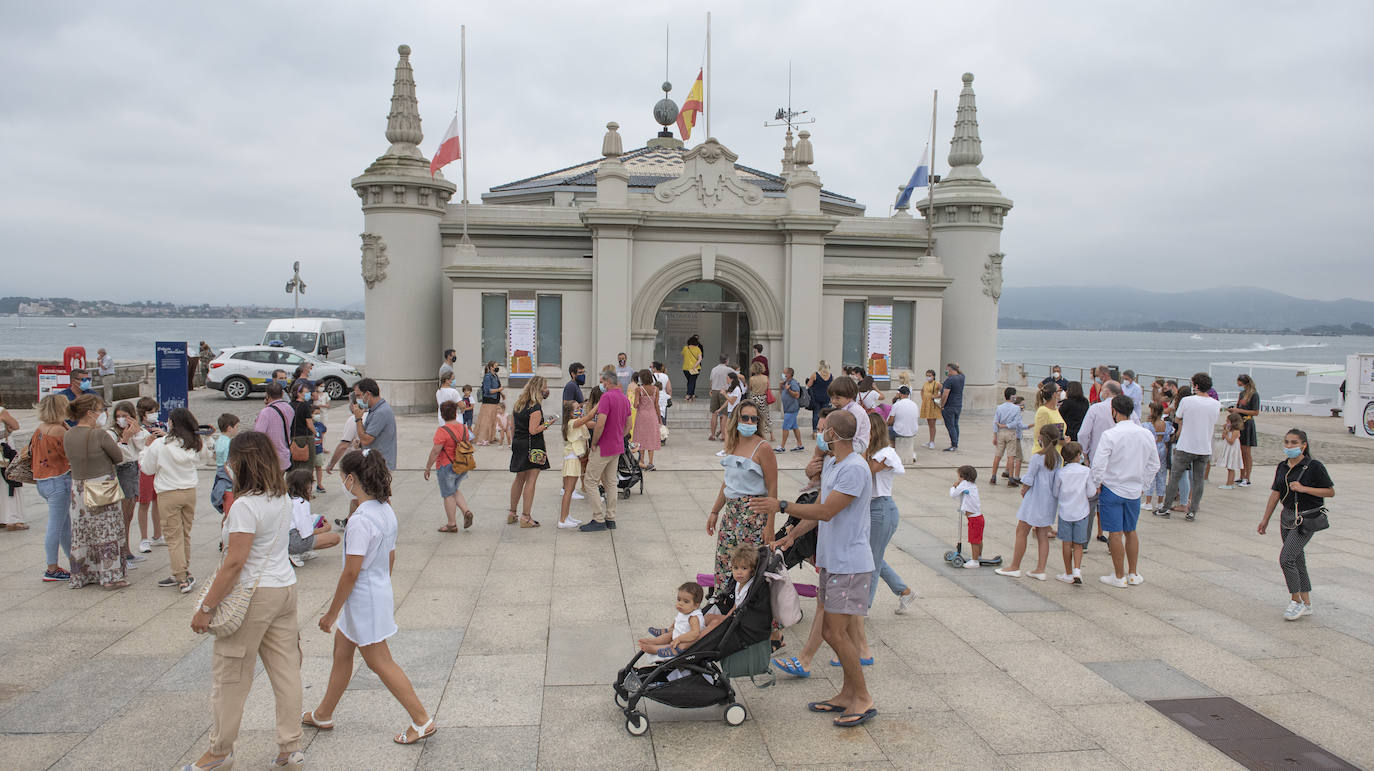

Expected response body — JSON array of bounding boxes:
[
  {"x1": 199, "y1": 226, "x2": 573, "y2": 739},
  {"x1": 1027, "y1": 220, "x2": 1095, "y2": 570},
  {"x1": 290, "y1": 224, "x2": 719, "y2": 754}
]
[{"x1": 0, "y1": 297, "x2": 363, "y2": 319}]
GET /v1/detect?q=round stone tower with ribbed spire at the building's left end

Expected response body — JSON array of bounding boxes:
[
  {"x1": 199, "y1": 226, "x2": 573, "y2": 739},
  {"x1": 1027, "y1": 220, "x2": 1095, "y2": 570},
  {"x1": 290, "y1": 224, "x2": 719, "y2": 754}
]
[{"x1": 352, "y1": 45, "x2": 453, "y2": 412}]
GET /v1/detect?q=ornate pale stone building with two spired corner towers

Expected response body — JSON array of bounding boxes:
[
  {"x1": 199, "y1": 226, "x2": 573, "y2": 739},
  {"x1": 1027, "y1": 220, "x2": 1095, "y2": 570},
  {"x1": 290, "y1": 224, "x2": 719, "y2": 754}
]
[{"x1": 352, "y1": 45, "x2": 1011, "y2": 410}]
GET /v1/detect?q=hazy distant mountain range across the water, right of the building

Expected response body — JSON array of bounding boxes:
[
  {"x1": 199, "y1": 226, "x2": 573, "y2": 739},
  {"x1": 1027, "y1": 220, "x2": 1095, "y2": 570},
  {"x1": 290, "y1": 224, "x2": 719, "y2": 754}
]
[{"x1": 998, "y1": 286, "x2": 1374, "y2": 335}]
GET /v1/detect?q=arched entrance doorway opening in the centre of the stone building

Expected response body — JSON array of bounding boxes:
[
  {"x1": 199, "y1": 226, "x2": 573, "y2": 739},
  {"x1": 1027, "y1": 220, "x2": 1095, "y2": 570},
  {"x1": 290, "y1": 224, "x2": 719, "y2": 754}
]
[{"x1": 654, "y1": 280, "x2": 752, "y2": 396}]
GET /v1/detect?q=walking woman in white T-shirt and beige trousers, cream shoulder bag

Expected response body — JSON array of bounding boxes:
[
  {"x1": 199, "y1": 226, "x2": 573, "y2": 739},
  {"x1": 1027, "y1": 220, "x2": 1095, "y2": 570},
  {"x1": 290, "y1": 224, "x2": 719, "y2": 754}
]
[{"x1": 188, "y1": 434, "x2": 305, "y2": 771}]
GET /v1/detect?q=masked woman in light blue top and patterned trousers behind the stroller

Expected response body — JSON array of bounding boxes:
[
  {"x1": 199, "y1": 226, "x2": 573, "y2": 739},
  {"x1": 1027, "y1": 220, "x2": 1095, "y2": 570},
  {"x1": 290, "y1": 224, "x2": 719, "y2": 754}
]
[{"x1": 706, "y1": 401, "x2": 778, "y2": 587}]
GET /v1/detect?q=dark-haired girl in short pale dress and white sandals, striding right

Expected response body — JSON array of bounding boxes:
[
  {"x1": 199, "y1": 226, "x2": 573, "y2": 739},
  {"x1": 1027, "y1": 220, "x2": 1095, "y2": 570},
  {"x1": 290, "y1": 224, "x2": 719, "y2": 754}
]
[{"x1": 301, "y1": 452, "x2": 437, "y2": 745}]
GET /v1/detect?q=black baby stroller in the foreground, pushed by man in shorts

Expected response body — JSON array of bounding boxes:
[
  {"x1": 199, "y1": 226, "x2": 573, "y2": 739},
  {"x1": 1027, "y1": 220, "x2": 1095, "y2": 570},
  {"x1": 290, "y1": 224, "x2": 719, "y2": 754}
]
[{"x1": 614, "y1": 548, "x2": 772, "y2": 737}]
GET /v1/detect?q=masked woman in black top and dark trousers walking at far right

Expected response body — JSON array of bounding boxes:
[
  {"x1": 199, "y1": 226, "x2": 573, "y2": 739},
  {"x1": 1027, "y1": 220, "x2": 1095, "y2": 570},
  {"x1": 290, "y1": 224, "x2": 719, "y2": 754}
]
[{"x1": 1256, "y1": 429, "x2": 1336, "y2": 621}]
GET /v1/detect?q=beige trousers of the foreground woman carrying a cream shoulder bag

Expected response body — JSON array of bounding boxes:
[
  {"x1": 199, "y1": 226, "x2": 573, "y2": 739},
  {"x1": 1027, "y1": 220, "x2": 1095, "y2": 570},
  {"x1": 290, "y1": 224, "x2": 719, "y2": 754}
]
[{"x1": 208, "y1": 582, "x2": 301, "y2": 756}]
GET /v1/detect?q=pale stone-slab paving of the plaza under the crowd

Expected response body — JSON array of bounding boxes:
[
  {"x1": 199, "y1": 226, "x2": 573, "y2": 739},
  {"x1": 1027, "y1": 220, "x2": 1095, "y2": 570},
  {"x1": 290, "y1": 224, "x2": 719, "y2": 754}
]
[{"x1": 0, "y1": 395, "x2": 1374, "y2": 771}]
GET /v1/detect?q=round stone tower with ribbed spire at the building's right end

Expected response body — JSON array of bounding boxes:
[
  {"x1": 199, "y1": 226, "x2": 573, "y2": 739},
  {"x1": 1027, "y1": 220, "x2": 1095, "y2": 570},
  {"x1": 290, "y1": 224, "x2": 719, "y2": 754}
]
[{"x1": 915, "y1": 73, "x2": 1011, "y2": 407}]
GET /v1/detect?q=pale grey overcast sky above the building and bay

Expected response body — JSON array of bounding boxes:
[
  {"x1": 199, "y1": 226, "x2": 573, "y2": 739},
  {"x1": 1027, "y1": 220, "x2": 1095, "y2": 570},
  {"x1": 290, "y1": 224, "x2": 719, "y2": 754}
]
[{"x1": 0, "y1": 0, "x2": 1374, "y2": 306}]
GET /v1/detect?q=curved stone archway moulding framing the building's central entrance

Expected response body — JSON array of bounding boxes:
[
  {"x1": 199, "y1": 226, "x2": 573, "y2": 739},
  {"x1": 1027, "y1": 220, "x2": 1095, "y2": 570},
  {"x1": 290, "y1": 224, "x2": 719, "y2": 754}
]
[{"x1": 629, "y1": 253, "x2": 783, "y2": 370}]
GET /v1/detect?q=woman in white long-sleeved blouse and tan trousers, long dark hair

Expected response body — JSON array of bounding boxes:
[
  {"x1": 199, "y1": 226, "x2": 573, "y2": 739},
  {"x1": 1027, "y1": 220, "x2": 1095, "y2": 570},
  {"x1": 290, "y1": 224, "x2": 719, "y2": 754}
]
[{"x1": 139, "y1": 407, "x2": 213, "y2": 594}]
